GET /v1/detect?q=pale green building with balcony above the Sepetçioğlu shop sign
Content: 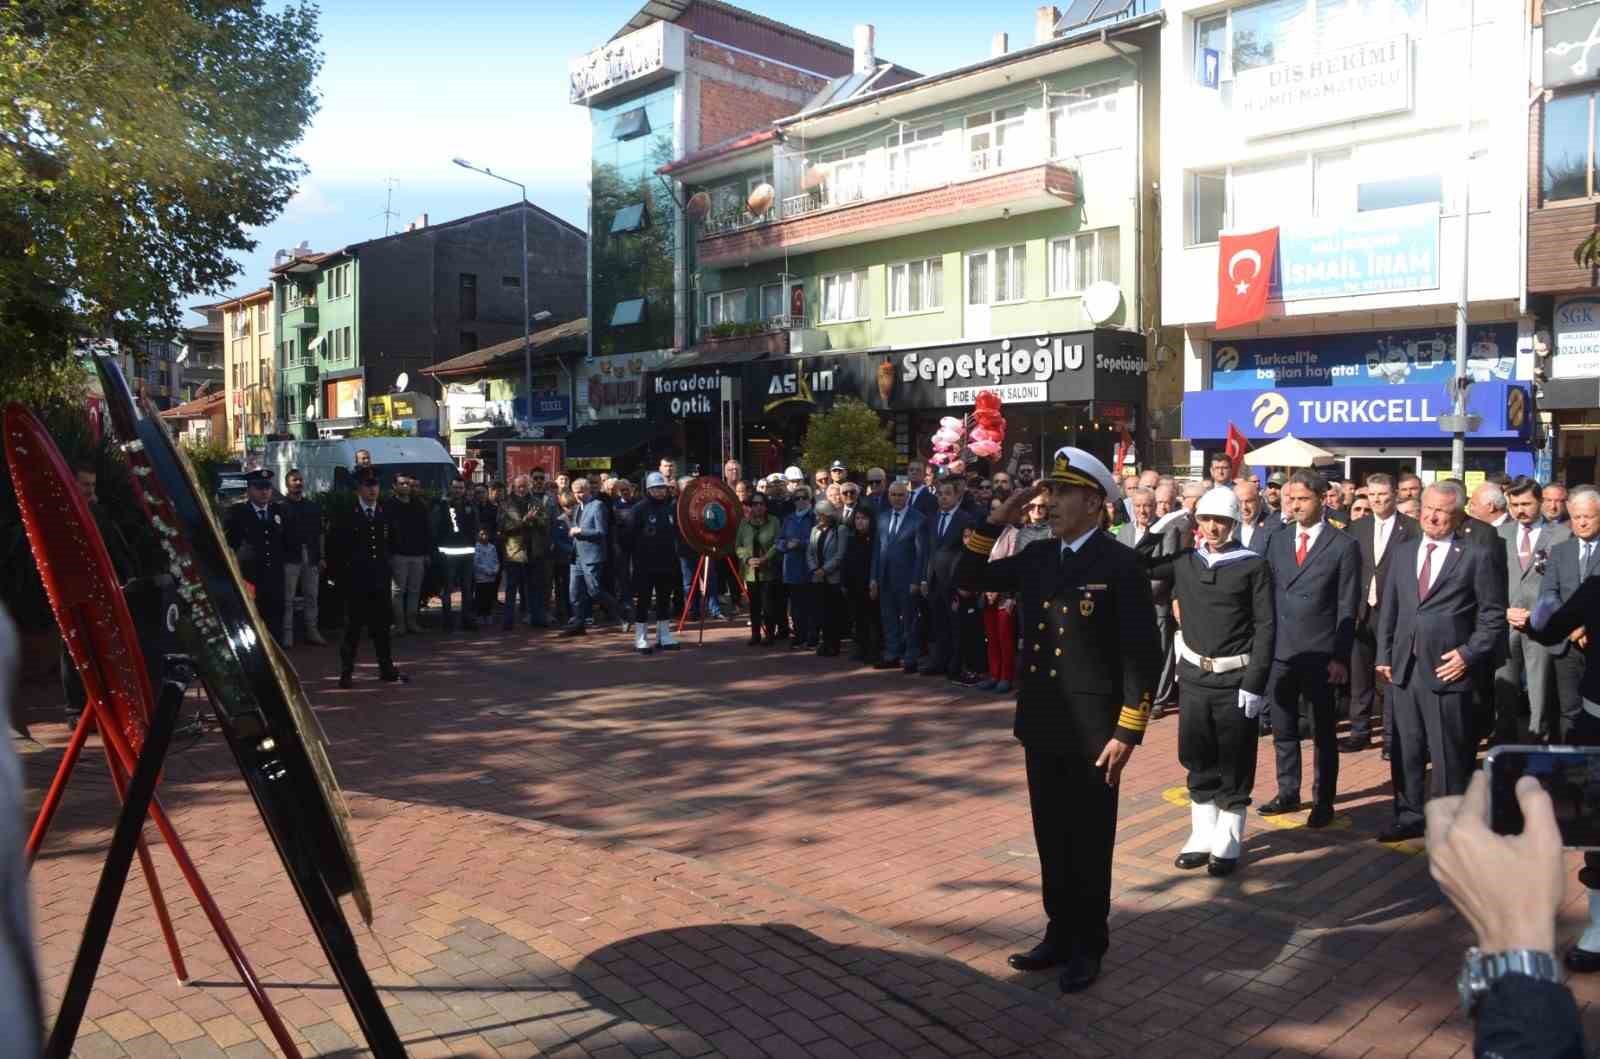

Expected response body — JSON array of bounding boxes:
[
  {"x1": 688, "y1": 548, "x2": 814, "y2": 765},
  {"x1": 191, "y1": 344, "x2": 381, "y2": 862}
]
[{"x1": 661, "y1": 8, "x2": 1181, "y2": 470}]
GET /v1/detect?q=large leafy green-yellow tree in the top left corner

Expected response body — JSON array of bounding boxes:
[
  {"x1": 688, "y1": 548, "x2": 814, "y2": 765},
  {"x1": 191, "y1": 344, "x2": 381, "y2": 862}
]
[{"x1": 0, "y1": 0, "x2": 322, "y2": 400}]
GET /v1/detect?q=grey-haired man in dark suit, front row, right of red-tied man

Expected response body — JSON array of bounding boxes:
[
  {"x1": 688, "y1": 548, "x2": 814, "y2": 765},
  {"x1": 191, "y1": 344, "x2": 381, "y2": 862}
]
[{"x1": 1378, "y1": 482, "x2": 1506, "y2": 841}]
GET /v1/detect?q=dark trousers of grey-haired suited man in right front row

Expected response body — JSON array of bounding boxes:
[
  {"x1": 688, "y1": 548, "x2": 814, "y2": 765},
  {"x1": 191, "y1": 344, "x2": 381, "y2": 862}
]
[{"x1": 1389, "y1": 684, "x2": 1477, "y2": 827}]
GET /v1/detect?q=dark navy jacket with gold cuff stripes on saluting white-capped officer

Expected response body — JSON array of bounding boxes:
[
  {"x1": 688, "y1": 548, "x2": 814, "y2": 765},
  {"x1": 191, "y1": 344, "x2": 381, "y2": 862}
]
[{"x1": 957, "y1": 522, "x2": 1162, "y2": 760}]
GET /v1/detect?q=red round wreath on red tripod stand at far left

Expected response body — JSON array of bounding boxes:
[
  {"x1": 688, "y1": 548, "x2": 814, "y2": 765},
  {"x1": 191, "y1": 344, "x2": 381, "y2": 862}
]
[{"x1": 5, "y1": 405, "x2": 301, "y2": 1059}]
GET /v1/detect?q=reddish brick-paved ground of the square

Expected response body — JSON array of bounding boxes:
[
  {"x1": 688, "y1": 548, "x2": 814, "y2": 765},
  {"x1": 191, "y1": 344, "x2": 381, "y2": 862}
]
[{"x1": 18, "y1": 617, "x2": 1600, "y2": 1059}]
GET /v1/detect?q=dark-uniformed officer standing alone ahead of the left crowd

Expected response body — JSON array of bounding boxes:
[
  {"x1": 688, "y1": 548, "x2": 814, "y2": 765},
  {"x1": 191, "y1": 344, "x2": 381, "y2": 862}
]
[{"x1": 328, "y1": 466, "x2": 406, "y2": 688}]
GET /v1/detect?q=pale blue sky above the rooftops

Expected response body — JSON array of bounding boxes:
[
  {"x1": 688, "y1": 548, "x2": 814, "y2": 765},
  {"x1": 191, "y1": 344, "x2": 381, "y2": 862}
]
[{"x1": 187, "y1": 0, "x2": 1056, "y2": 321}]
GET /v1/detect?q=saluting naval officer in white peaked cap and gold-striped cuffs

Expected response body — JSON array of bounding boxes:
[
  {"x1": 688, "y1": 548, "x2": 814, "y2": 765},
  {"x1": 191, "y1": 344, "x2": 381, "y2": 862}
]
[{"x1": 957, "y1": 448, "x2": 1162, "y2": 993}]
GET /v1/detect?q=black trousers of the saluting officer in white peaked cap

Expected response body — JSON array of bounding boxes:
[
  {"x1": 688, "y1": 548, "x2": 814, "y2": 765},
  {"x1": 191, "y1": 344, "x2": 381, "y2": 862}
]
[{"x1": 1026, "y1": 750, "x2": 1117, "y2": 958}]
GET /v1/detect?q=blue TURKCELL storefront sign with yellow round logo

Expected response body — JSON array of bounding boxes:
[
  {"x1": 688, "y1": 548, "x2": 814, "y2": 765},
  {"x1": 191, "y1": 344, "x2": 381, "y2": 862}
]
[{"x1": 1184, "y1": 382, "x2": 1526, "y2": 442}]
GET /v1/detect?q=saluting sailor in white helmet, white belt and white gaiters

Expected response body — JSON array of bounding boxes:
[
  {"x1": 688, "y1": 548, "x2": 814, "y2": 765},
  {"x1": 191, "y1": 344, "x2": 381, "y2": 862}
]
[{"x1": 1138, "y1": 486, "x2": 1274, "y2": 875}]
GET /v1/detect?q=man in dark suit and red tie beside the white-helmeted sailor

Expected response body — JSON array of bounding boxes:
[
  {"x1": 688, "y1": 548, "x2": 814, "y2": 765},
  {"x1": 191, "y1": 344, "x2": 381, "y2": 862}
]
[{"x1": 1261, "y1": 470, "x2": 1362, "y2": 827}]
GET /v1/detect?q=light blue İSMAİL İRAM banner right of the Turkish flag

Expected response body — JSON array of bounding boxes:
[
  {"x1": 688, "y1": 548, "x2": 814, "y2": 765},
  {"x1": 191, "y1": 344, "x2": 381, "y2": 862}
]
[{"x1": 1274, "y1": 203, "x2": 1438, "y2": 301}]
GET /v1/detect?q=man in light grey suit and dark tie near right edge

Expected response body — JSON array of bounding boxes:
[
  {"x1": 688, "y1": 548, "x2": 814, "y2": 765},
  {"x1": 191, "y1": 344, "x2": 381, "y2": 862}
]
[{"x1": 1494, "y1": 477, "x2": 1573, "y2": 742}]
